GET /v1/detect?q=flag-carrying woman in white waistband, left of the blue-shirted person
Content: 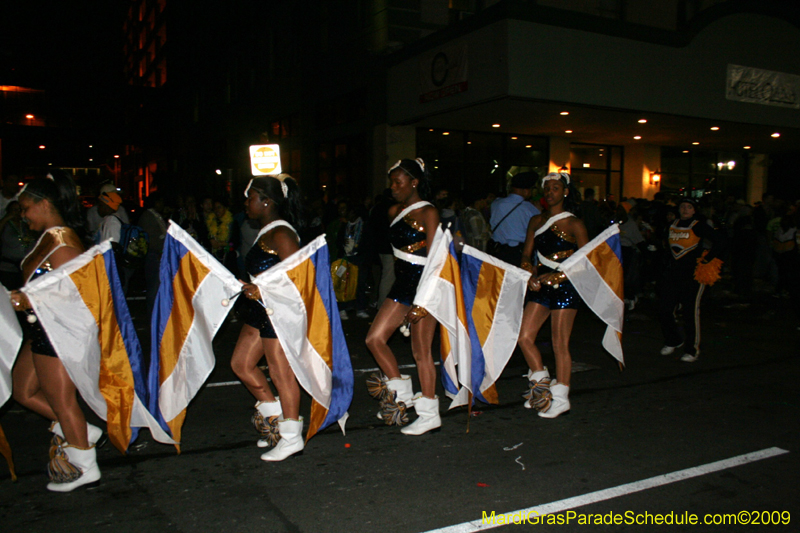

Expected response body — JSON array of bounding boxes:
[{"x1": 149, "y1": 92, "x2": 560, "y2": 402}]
[{"x1": 366, "y1": 159, "x2": 441, "y2": 435}]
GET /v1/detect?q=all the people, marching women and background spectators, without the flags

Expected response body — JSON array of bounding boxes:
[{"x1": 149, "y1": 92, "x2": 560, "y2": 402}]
[{"x1": 0, "y1": 163, "x2": 800, "y2": 492}]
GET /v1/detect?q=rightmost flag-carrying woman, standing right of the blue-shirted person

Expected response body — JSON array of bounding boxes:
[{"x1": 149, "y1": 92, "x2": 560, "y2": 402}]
[{"x1": 518, "y1": 172, "x2": 589, "y2": 418}]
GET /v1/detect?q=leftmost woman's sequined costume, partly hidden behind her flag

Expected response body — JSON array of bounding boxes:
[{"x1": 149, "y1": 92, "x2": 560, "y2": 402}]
[{"x1": 20, "y1": 226, "x2": 84, "y2": 357}]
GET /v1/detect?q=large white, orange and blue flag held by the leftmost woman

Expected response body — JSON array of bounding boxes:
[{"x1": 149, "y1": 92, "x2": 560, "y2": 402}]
[{"x1": 22, "y1": 241, "x2": 174, "y2": 453}]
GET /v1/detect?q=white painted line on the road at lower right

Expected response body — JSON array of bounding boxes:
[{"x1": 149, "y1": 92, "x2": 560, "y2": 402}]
[{"x1": 427, "y1": 448, "x2": 789, "y2": 533}]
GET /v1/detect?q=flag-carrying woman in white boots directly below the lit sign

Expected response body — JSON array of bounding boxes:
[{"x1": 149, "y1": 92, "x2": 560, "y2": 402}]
[{"x1": 231, "y1": 174, "x2": 303, "y2": 461}]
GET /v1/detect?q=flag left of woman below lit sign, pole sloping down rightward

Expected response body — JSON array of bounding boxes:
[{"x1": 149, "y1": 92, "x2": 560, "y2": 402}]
[{"x1": 147, "y1": 222, "x2": 242, "y2": 443}]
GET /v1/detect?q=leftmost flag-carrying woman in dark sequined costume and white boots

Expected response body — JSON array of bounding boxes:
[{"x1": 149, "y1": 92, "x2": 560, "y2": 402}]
[{"x1": 10, "y1": 171, "x2": 103, "y2": 492}]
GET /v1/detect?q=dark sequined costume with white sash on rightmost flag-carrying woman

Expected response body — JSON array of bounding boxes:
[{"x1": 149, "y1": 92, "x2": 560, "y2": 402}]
[{"x1": 526, "y1": 211, "x2": 580, "y2": 309}]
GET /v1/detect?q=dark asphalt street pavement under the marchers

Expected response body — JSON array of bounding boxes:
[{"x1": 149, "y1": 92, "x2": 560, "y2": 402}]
[{"x1": 0, "y1": 280, "x2": 800, "y2": 533}]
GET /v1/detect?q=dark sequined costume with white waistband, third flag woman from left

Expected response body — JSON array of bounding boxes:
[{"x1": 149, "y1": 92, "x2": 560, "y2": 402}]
[{"x1": 386, "y1": 202, "x2": 432, "y2": 305}]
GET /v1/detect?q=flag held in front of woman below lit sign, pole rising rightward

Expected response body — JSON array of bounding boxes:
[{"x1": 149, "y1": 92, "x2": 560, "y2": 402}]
[{"x1": 253, "y1": 235, "x2": 353, "y2": 440}]
